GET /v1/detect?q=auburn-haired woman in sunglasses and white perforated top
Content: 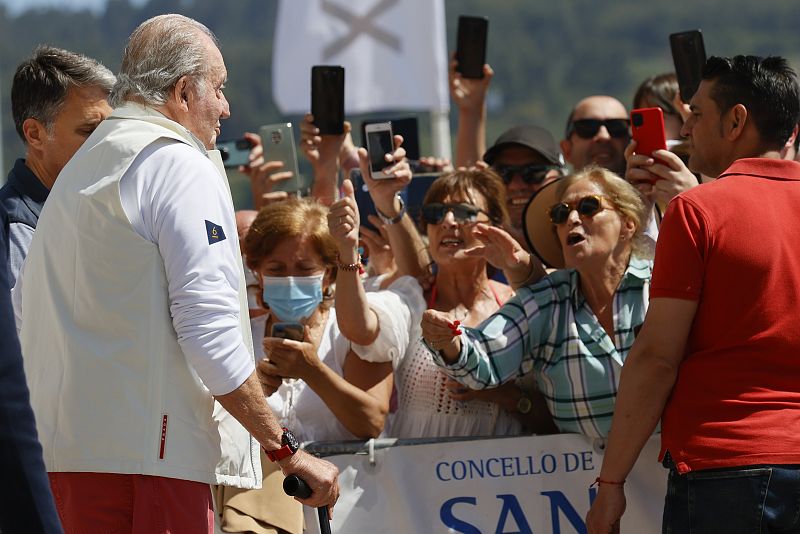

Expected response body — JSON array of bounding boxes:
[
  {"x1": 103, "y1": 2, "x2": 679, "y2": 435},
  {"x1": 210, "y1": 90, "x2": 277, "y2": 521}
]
[{"x1": 362, "y1": 165, "x2": 552, "y2": 438}]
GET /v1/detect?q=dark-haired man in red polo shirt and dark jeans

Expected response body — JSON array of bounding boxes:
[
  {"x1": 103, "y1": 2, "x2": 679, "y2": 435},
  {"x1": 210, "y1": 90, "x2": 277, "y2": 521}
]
[{"x1": 587, "y1": 56, "x2": 800, "y2": 534}]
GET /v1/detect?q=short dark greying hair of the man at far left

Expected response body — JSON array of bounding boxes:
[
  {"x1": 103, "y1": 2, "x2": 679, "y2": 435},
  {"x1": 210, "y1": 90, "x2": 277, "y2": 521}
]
[{"x1": 11, "y1": 45, "x2": 116, "y2": 142}]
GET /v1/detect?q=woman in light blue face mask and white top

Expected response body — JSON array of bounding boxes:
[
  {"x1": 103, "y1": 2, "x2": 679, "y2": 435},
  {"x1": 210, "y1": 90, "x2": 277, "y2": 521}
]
[{"x1": 212, "y1": 198, "x2": 407, "y2": 533}]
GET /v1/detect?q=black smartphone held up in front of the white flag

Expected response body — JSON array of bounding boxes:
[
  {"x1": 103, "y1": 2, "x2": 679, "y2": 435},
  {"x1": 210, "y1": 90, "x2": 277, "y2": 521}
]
[{"x1": 311, "y1": 65, "x2": 344, "y2": 135}]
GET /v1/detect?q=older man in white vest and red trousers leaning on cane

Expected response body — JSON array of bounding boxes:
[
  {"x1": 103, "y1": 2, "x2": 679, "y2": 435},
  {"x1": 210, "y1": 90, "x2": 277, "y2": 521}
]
[{"x1": 21, "y1": 15, "x2": 339, "y2": 533}]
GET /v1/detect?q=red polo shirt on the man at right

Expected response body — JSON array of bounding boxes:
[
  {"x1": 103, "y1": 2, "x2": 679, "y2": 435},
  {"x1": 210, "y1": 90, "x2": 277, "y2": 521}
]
[{"x1": 650, "y1": 158, "x2": 800, "y2": 472}]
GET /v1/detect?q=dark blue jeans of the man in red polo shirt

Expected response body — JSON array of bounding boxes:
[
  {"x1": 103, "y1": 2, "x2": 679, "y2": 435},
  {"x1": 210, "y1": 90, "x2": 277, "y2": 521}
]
[{"x1": 662, "y1": 458, "x2": 800, "y2": 534}]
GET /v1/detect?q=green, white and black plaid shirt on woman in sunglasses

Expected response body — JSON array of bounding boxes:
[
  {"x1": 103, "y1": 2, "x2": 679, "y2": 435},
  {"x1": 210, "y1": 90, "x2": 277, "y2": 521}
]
[{"x1": 434, "y1": 258, "x2": 653, "y2": 437}]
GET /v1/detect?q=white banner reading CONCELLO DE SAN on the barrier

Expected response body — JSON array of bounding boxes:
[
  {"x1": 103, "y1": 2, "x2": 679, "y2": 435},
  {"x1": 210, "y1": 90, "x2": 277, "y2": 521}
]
[{"x1": 306, "y1": 434, "x2": 667, "y2": 534}]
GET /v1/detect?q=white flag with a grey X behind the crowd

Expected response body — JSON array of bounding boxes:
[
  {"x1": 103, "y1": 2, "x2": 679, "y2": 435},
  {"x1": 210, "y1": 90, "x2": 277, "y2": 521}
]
[{"x1": 272, "y1": 0, "x2": 449, "y2": 115}]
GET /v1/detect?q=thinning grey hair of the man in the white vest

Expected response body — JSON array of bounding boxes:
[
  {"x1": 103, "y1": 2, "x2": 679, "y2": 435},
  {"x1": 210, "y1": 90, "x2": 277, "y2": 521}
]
[{"x1": 111, "y1": 14, "x2": 218, "y2": 107}]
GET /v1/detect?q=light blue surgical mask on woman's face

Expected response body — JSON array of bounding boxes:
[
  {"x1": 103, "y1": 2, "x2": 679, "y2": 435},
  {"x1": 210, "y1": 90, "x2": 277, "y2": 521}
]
[{"x1": 262, "y1": 274, "x2": 324, "y2": 323}]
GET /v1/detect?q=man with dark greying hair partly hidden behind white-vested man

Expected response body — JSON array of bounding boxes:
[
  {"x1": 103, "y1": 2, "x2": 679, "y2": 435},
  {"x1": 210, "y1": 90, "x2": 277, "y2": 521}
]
[{"x1": 0, "y1": 46, "x2": 115, "y2": 287}]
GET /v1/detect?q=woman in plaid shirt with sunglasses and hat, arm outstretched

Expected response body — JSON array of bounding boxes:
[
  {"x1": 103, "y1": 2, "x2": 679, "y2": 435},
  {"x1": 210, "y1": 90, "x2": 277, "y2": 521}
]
[{"x1": 422, "y1": 167, "x2": 652, "y2": 437}]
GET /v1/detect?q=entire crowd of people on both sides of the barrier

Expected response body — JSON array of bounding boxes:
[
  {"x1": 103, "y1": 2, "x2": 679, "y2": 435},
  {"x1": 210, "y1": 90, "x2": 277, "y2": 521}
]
[{"x1": 0, "y1": 8, "x2": 800, "y2": 533}]
